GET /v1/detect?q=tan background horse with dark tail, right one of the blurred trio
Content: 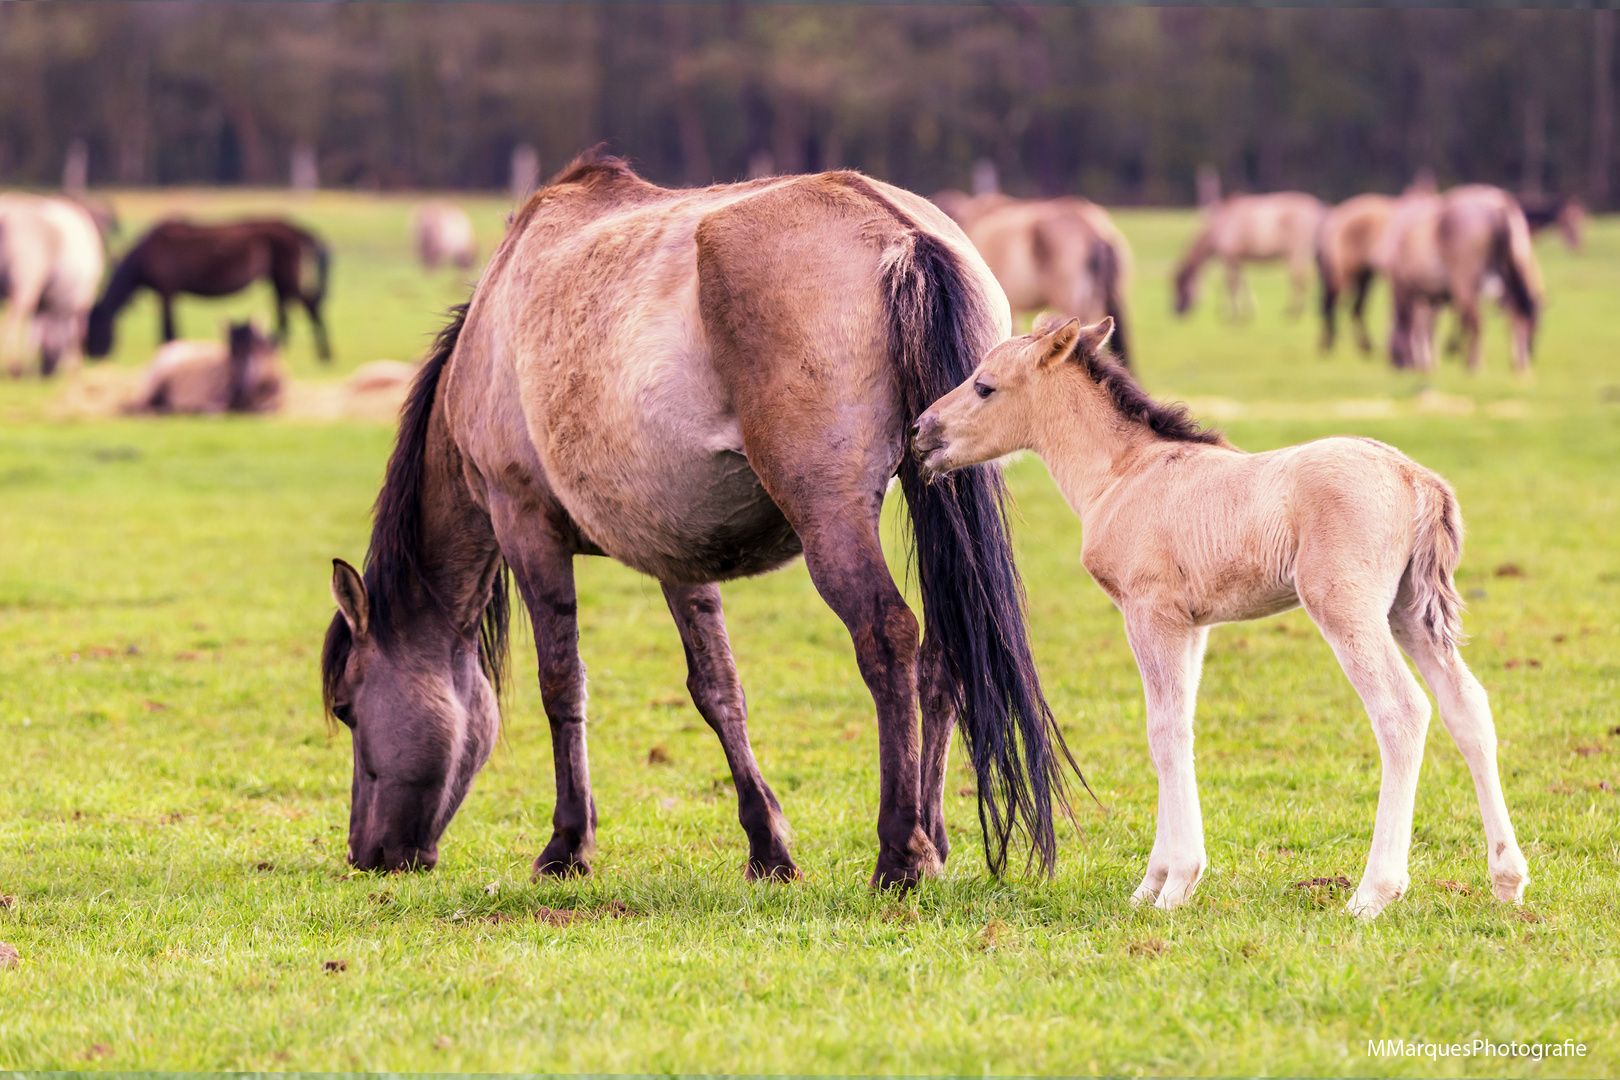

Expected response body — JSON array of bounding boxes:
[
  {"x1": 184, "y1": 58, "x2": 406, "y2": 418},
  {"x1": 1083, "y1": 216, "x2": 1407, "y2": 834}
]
[{"x1": 1377, "y1": 185, "x2": 1542, "y2": 371}]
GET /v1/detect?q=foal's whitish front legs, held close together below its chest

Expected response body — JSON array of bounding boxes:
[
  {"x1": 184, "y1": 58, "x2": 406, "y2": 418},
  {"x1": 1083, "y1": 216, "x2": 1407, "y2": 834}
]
[{"x1": 1126, "y1": 614, "x2": 1210, "y2": 912}]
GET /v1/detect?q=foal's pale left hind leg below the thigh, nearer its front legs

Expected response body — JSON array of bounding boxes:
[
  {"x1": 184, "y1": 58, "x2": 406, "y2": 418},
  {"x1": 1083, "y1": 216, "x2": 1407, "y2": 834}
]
[{"x1": 1306, "y1": 615, "x2": 1429, "y2": 918}]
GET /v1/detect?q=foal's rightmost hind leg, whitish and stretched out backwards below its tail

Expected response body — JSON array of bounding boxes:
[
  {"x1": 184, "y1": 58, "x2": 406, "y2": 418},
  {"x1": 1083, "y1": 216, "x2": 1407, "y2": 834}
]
[{"x1": 1390, "y1": 602, "x2": 1529, "y2": 904}]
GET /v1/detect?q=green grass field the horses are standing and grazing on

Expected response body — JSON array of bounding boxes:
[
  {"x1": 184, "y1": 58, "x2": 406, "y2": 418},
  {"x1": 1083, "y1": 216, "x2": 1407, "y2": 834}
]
[{"x1": 0, "y1": 193, "x2": 1620, "y2": 1075}]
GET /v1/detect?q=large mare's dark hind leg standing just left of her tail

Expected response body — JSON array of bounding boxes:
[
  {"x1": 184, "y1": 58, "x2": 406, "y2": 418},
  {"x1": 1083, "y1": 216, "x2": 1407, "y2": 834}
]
[{"x1": 800, "y1": 515, "x2": 941, "y2": 889}]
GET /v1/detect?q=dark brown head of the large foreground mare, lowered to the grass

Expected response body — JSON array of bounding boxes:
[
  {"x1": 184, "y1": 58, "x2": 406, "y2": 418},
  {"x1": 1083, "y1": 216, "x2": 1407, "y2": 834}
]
[{"x1": 321, "y1": 559, "x2": 505, "y2": 870}]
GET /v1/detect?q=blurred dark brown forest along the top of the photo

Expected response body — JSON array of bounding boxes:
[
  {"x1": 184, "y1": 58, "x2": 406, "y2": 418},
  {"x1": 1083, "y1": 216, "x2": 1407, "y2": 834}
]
[{"x1": 0, "y1": 0, "x2": 1615, "y2": 207}]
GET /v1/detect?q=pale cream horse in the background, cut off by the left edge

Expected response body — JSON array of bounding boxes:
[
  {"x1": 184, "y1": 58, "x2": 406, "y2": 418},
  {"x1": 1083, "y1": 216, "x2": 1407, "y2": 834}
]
[{"x1": 0, "y1": 194, "x2": 107, "y2": 377}]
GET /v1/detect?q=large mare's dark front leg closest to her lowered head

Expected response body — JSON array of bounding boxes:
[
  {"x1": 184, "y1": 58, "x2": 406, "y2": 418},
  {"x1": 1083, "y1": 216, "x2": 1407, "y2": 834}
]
[{"x1": 501, "y1": 536, "x2": 596, "y2": 874}]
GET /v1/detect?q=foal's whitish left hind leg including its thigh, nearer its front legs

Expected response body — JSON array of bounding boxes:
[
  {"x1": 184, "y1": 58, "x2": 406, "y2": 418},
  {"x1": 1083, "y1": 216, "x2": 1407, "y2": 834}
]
[{"x1": 1296, "y1": 569, "x2": 1429, "y2": 918}]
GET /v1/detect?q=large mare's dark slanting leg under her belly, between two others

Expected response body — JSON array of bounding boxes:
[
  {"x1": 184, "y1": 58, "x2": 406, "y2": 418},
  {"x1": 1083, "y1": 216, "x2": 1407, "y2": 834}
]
[{"x1": 664, "y1": 583, "x2": 800, "y2": 881}]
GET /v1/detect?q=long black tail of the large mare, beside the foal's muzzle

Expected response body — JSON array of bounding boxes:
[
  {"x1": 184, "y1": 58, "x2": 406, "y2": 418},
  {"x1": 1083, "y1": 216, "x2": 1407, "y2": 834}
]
[{"x1": 873, "y1": 213, "x2": 1077, "y2": 873}]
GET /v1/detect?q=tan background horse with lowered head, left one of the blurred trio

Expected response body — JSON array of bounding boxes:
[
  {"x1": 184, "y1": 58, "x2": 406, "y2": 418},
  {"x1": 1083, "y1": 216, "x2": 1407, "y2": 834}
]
[{"x1": 1176, "y1": 191, "x2": 1327, "y2": 319}]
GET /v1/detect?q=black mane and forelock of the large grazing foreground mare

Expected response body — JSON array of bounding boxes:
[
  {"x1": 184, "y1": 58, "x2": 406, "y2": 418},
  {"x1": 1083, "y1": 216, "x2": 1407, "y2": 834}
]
[{"x1": 321, "y1": 304, "x2": 512, "y2": 714}]
